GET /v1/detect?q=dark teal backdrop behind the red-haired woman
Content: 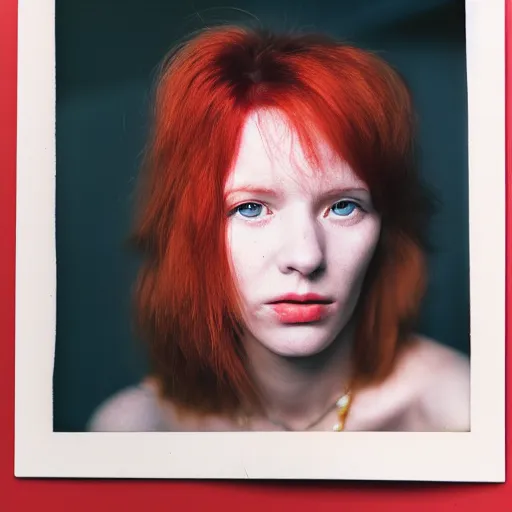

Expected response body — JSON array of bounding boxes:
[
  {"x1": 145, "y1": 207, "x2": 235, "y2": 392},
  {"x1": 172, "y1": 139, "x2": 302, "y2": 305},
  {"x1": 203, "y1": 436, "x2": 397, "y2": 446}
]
[{"x1": 54, "y1": 0, "x2": 469, "y2": 431}]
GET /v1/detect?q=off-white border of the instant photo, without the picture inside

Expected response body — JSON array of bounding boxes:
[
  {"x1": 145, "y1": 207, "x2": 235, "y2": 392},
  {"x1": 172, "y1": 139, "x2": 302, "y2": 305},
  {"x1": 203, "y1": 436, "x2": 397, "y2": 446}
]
[{"x1": 15, "y1": 0, "x2": 505, "y2": 482}]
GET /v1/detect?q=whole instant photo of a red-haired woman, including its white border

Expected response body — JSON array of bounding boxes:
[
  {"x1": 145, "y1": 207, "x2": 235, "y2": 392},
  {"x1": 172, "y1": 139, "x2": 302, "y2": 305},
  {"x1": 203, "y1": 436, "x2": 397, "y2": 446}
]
[{"x1": 15, "y1": 0, "x2": 506, "y2": 482}]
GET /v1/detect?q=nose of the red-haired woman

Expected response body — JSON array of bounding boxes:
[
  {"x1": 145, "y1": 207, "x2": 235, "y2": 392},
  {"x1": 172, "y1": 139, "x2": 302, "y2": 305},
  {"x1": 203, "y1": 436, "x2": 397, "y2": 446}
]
[{"x1": 278, "y1": 212, "x2": 326, "y2": 279}]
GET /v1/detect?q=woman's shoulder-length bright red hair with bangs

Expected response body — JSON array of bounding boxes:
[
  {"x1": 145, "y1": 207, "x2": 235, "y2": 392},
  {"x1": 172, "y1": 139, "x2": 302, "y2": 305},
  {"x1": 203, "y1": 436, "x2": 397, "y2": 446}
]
[{"x1": 130, "y1": 27, "x2": 429, "y2": 413}]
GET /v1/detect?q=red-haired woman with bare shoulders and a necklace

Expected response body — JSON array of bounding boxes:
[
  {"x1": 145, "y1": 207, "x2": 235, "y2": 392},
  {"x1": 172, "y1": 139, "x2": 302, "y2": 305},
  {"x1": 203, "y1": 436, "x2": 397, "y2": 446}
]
[{"x1": 90, "y1": 27, "x2": 469, "y2": 431}]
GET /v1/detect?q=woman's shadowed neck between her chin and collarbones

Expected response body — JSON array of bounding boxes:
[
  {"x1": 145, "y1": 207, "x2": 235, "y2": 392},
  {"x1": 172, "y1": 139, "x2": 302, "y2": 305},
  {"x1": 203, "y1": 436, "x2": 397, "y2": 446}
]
[{"x1": 244, "y1": 329, "x2": 352, "y2": 430}]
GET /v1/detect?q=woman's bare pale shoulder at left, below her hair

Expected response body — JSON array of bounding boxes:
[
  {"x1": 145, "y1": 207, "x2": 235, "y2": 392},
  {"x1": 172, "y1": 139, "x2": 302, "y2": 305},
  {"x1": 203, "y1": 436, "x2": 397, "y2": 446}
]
[{"x1": 87, "y1": 383, "x2": 165, "y2": 432}]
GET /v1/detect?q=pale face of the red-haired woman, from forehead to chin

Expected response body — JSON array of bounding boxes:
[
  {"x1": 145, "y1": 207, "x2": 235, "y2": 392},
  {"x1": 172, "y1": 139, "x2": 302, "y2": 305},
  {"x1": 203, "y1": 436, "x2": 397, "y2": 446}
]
[{"x1": 225, "y1": 112, "x2": 380, "y2": 356}]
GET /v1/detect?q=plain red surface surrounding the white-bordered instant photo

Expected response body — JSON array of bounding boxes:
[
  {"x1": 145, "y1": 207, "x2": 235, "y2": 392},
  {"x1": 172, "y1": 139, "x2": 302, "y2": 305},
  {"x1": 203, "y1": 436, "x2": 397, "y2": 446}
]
[{"x1": 0, "y1": 0, "x2": 512, "y2": 512}]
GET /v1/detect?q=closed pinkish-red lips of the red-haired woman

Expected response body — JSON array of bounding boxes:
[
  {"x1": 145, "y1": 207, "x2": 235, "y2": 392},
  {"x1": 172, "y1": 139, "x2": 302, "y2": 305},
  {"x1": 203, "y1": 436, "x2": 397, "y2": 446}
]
[{"x1": 268, "y1": 293, "x2": 333, "y2": 324}]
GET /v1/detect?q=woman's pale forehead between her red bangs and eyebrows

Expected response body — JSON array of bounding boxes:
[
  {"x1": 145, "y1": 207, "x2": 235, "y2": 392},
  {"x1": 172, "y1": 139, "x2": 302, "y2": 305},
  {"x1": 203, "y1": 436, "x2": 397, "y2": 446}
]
[{"x1": 226, "y1": 110, "x2": 366, "y2": 191}]
